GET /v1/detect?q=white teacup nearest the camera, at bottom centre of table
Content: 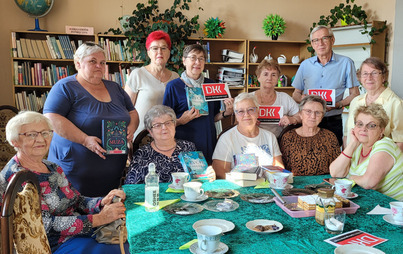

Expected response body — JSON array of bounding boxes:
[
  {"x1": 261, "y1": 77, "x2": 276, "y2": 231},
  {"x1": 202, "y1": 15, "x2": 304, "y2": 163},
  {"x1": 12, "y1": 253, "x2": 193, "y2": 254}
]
[{"x1": 196, "y1": 225, "x2": 222, "y2": 253}]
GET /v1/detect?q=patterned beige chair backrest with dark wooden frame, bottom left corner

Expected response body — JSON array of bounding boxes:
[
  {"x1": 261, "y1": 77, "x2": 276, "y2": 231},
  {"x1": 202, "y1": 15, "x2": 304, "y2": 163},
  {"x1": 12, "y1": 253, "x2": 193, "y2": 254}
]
[{"x1": 1, "y1": 170, "x2": 51, "y2": 254}]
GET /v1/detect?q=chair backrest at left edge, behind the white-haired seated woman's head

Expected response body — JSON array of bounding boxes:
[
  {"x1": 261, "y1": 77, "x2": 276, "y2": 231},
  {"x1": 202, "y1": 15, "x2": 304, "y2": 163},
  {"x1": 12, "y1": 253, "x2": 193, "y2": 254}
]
[{"x1": 0, "y1": 105, "x2": 18, "y2": 170}]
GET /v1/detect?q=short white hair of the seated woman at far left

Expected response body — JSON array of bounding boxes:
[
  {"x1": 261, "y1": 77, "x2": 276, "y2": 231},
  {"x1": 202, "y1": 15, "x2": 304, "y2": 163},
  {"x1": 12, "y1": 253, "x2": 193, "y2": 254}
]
[{"x1": 6, "y1": 111, "x2": 53, "y2": 151}]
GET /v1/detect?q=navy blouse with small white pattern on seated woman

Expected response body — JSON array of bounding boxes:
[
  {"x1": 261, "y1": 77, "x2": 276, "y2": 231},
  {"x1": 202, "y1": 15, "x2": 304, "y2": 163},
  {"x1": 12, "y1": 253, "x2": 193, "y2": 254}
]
[{"x1": 125, "y1": 139, "x2": 196, "y2": 184}]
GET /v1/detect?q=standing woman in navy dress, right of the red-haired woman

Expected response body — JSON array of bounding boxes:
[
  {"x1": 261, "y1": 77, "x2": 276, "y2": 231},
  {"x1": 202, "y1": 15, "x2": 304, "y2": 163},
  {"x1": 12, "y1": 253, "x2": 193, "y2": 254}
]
[{"x1": 163, "y1": 44, "x2": 233, "y2": 165}]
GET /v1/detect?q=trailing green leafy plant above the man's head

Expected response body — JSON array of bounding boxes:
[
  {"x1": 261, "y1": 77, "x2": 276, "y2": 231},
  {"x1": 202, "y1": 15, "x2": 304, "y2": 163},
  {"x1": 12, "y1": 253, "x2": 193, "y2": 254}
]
[{"x1": 306, "y1": 0, "x2": 387, "y2": 55}]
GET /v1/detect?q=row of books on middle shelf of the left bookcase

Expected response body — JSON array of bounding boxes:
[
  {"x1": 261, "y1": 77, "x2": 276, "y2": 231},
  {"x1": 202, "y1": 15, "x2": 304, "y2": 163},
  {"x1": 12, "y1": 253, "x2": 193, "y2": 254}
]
[{"x1": 13, "y1": 61, "x2": 75, "y2": 86}]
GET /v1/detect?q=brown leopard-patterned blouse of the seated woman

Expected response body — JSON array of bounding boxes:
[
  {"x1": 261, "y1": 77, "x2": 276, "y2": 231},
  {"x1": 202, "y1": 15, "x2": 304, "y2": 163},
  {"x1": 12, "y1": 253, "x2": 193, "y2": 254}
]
[{"x1": 280, "y1": 128, "x2": 341, "y2": 176}]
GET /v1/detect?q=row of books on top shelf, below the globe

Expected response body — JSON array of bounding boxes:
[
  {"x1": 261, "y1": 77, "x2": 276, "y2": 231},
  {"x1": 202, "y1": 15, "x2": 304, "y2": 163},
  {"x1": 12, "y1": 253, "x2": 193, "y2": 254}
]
[{"x1": 11, "y1": 32, "x2": 83, "y2": 59}]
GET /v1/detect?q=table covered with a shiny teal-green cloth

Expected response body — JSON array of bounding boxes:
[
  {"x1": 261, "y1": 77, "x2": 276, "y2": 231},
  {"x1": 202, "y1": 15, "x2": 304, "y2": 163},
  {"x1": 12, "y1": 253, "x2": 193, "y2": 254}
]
[{"x1": 123, "y1": 175, "x2": 403, "y2": 254}]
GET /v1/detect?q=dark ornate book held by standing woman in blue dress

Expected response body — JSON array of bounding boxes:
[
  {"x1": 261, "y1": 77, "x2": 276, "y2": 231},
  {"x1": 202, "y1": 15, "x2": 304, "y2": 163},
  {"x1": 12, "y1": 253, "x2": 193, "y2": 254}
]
[{"x1": 102, "y1": 120, "x2": 127, "y2": 154}]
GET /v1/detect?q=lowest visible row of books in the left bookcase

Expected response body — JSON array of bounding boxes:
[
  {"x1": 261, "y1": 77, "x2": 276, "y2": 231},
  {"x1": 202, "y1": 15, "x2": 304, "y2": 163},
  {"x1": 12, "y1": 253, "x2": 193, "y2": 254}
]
[{"x1": 15, "y1": 91, "x2": 49, "y2": 111}]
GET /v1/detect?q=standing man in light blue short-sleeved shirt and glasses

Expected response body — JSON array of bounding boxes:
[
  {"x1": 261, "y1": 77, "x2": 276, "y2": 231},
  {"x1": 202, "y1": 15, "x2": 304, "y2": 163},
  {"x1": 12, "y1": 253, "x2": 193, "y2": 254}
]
[{"x1": 292, "y1": 26, "x2": 359, "y2": 146}]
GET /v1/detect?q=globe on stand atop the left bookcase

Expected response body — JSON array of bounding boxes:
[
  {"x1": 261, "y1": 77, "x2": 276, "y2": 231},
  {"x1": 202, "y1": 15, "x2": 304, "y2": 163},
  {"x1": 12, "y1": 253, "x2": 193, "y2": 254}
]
[{"x1": 14, "y1": 0, "x2": 54, "y2": 31}]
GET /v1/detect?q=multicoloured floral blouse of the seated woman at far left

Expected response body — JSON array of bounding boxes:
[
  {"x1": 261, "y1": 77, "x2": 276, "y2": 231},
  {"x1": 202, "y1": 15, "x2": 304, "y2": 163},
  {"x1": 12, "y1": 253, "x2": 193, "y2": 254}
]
[{"x1": 0, "y1": 156, "x2": 102, "y2": 252}]
